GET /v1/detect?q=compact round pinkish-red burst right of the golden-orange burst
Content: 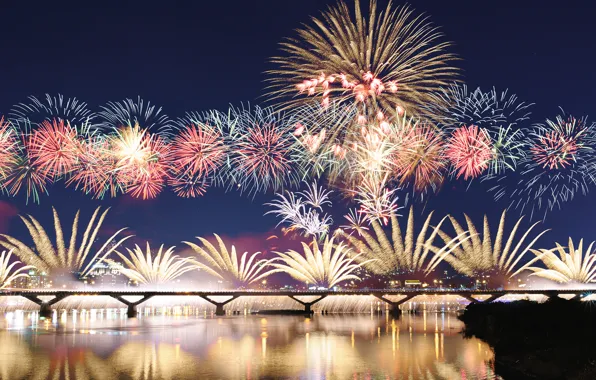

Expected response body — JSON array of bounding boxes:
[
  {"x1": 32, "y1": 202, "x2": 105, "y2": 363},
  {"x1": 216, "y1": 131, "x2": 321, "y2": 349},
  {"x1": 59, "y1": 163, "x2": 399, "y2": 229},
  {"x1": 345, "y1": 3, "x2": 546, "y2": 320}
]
[{"x1": 445, "y1": 125, "x2": 494, "y2": 180}]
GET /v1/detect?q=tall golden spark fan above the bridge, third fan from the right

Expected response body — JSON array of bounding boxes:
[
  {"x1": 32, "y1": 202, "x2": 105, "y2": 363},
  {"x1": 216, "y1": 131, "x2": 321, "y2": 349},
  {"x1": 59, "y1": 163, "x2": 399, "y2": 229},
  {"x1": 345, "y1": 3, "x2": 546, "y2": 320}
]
[{"x1": 340, "y1": 207, "x2": 469, "y2": 277}]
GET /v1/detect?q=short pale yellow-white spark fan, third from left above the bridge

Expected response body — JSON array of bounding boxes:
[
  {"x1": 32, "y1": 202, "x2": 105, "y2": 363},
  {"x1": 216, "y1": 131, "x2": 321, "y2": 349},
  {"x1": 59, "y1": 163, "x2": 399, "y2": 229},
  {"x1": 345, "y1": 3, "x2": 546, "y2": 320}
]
[{"x1": 110, "y1": 242, "x2": 196, "y2": 285}]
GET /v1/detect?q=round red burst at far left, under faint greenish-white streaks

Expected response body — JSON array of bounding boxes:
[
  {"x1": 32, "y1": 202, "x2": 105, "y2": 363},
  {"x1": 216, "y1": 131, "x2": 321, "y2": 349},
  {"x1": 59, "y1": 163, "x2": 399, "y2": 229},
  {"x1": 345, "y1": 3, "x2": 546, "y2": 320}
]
[{"x1": 27, "y1": 119, "x2": 80, "y2": 177}]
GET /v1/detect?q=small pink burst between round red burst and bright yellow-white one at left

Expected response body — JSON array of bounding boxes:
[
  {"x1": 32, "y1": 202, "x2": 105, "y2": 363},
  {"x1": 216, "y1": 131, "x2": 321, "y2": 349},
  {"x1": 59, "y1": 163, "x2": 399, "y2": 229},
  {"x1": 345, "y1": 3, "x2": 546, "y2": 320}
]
[{"x1": 66, "y1": 138, "x2": 122, "y2": 199}]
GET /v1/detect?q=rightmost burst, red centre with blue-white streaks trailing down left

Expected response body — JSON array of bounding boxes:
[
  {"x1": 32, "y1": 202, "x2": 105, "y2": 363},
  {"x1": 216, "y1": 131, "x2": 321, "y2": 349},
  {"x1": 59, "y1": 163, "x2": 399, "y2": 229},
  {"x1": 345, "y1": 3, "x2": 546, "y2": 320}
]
[{"x1": 491, "y1": 114, "x2": 596, "y2": 219}]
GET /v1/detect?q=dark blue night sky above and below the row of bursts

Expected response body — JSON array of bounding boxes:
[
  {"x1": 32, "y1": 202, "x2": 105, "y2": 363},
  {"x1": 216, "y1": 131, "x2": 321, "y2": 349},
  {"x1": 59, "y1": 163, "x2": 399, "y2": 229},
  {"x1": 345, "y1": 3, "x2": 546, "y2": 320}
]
[{"x1": 0, "y1": 0, "x2": 596, "y2": 255}]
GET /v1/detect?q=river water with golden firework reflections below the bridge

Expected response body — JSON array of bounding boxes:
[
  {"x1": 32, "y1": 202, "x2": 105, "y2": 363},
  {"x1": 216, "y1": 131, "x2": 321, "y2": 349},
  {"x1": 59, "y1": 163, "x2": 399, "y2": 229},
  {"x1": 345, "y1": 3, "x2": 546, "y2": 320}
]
[{"x1": 0, "y1": 310, "x2": 500, "y2": 380}]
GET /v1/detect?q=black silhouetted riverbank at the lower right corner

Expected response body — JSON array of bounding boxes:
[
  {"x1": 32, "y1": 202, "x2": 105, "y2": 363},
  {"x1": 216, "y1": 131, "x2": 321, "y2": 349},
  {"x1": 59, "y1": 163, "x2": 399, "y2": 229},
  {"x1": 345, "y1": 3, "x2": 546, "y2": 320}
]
[{"x1": 460, "y1": 298, "x2": 596, "y2": 380}]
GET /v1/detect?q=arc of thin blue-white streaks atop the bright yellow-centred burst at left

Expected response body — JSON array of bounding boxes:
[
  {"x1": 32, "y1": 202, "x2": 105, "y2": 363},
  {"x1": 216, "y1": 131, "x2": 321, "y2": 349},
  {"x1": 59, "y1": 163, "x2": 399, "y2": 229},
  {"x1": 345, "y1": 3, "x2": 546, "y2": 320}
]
[{"x1": 98, "y1": 97, "x2": 176, "y2": 137}]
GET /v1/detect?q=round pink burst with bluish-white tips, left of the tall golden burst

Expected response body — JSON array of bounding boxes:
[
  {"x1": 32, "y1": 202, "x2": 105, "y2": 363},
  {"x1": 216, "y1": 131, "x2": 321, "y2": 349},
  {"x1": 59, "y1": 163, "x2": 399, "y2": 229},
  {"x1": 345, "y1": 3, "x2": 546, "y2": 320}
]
[{"x1": 235, "y1": 123, "x2": 292, "y2": 188}]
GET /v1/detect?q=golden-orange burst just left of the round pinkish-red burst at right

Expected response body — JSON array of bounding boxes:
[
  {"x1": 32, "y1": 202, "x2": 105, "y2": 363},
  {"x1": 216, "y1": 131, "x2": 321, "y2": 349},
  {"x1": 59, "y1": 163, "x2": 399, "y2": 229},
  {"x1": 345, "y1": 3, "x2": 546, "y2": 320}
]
[{"x1": 393, "y1": 123, "x2": 447, "y2": 192}]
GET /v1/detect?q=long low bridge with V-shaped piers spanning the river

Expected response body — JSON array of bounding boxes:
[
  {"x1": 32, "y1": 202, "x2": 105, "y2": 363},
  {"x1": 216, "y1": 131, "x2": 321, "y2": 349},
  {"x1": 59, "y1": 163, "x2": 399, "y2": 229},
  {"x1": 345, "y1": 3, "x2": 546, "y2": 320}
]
[{"x1": 0, "y1": 289, "x2": 596, "y2": 317}]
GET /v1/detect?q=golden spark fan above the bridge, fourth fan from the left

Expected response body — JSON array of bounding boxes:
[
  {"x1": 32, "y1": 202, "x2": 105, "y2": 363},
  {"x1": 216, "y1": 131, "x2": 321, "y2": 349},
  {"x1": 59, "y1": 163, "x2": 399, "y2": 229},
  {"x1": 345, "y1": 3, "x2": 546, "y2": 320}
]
[{"x1": 184, "y1": 234, "x2": 271, "y2": 288}]
